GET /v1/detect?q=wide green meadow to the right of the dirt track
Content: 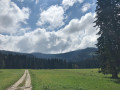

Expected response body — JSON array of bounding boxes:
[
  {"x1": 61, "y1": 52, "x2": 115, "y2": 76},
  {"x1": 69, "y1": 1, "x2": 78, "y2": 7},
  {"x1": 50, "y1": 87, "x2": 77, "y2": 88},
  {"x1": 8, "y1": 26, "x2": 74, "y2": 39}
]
[{"x1": 30, "y1": 69, "x2": 120, "y2": 90}]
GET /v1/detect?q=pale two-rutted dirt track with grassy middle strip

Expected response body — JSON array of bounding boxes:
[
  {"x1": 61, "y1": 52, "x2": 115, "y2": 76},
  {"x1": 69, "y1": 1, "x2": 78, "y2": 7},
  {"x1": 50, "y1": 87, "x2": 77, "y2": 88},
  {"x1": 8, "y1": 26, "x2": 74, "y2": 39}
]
[{"x1": 6, "y1": 70, "x2": 32, "y2": 90}]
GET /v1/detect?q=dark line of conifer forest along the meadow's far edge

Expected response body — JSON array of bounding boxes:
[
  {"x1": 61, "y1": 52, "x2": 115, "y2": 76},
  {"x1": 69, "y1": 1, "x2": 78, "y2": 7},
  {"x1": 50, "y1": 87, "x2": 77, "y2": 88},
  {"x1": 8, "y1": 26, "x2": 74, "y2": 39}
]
[{"x1": 0, "y1": 53, "x2": 99, "y2": 69}]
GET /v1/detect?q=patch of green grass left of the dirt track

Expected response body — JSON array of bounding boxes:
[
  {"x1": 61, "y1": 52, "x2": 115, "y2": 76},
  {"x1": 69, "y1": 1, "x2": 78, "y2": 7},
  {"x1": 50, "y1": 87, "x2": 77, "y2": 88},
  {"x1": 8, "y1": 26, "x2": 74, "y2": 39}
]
[{"x1": 0, "y1": 69, "x2": 24, "y2": 90}]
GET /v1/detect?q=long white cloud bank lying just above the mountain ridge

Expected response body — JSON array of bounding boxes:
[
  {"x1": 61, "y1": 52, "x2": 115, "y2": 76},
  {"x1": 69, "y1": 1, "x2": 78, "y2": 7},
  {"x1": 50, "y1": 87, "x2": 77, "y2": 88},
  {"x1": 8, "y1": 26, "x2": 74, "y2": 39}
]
[{"x1": 0, "y1": 13, "x2": 98, "y2": 53}]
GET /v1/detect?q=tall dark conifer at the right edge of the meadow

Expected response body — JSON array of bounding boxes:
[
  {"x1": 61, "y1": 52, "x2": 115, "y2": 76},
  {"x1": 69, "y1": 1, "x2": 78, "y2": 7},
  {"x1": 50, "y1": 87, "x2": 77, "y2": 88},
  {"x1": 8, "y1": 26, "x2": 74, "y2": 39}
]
[{"x1": 95, "y1": 0, "x2": 120, "y2": 78}]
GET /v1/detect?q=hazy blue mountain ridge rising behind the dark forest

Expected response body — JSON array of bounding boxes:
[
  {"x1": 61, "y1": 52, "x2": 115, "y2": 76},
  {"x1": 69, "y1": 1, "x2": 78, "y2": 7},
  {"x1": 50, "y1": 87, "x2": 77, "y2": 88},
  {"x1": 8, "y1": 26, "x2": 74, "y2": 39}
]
[{"x1": 0, "y1": 48, "x2": 97, "y2": 62}]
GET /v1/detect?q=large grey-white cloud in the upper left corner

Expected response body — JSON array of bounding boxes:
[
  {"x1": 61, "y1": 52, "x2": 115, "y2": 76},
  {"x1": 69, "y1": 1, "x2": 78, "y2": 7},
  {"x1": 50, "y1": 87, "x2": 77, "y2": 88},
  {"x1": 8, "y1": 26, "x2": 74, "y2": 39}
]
[{"x1": 0, "y1": 0, "x2": 30, "y2": 33}]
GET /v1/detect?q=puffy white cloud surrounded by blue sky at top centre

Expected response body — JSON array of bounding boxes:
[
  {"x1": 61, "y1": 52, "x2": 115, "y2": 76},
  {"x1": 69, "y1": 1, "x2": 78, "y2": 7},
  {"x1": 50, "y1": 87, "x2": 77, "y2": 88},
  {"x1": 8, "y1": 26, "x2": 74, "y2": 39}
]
[{"x1": 37, "y1": 5, "x2": 64, "y2": 30}]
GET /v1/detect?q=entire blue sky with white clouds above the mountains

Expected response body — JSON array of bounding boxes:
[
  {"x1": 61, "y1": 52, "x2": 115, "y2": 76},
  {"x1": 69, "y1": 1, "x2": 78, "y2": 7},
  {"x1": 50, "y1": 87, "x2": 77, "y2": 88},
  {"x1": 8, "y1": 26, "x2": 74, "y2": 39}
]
[{"x1": 0, "y1": 0, "x2": 98, "y2": 54}]
